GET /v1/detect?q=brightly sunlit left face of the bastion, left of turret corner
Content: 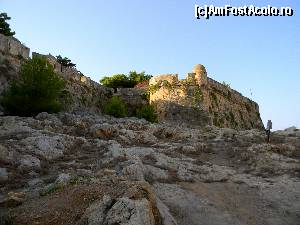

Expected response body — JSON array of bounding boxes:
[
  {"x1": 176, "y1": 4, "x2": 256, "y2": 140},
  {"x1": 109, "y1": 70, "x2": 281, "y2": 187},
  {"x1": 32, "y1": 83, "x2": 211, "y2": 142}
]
[{"x1": 149, "y1": 74, "x2": 211, "y2": 125}]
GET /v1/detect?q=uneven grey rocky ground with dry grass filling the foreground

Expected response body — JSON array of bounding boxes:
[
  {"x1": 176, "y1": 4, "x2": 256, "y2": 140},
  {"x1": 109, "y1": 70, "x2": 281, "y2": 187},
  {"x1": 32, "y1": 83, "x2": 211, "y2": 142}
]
[{"x1": 0, "y1": 113, "x2": 300, "y2": 225}]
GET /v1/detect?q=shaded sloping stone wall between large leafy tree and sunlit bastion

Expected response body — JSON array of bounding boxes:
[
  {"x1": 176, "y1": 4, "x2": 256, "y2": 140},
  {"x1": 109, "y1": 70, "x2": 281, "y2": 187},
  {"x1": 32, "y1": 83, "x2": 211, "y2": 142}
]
[{"x1": 32, "y1": 53, "x2": 148, "y2": 116}]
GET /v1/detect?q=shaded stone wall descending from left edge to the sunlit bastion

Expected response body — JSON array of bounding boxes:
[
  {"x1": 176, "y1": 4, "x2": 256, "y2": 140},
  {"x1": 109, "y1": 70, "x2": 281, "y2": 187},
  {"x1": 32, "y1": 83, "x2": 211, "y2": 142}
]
[{"x1": 0, "y1": 34, "x2": 148, "y2": 116}]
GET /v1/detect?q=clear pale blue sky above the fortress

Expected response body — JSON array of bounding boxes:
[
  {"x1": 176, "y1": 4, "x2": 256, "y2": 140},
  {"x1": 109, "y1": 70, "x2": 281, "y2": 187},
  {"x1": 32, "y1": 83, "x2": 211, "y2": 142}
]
[{"x1": 0, "y1": 0, "x2": 300, "y2": 129}]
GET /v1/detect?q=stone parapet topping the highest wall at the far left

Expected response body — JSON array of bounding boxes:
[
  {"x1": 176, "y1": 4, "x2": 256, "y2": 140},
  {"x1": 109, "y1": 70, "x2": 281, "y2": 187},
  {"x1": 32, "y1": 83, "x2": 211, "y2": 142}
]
[{"x1": 0, "y1": 34, "x2": 30, "y2": 59}]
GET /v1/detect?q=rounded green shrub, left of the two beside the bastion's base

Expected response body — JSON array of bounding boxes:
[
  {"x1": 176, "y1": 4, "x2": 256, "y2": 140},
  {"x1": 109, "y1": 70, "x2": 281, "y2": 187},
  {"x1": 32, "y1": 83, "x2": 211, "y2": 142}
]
[{"x1": 104, "y1": 96, "x2": 127, "y2": 118}]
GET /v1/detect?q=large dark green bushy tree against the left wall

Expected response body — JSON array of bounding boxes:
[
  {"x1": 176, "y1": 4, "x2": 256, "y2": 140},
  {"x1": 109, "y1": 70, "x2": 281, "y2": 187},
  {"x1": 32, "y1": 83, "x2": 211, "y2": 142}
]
[{"x1": 1, "y1": 56, "x2": 64, "y2": 116}]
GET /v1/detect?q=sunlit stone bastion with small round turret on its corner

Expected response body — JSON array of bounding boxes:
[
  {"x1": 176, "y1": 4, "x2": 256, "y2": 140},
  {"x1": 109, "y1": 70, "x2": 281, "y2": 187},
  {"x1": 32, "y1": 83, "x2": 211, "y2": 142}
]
[{"x1": 149, "y1": 64, "x2": 264, "y2": 129}]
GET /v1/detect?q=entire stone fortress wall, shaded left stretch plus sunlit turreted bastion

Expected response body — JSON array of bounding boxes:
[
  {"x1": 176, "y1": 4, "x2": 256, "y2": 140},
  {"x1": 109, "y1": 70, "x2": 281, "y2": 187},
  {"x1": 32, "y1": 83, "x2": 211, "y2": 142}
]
[{"x1": 0, "y1": 34, "x2": 263, "y2": 129}]
